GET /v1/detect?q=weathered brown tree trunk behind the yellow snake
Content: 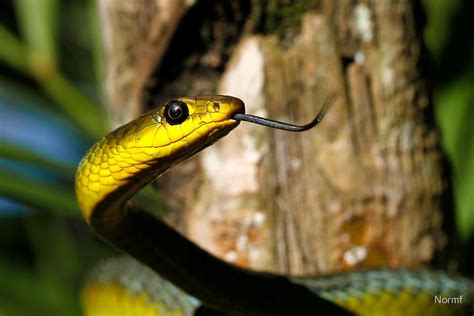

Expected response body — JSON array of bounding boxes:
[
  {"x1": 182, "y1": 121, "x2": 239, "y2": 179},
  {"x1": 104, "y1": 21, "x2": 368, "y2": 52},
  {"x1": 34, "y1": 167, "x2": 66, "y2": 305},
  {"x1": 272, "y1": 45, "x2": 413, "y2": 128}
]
[{"x1": 99, "y1": 0, "x2": 452, "y2": 275}]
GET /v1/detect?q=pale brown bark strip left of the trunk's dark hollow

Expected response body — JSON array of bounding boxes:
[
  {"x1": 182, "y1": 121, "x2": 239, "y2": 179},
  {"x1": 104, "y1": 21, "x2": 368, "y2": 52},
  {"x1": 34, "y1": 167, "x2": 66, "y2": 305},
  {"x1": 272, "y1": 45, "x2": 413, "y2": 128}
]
[{"x1": 97, "y1": 0, "x2": 194, "y2": 126}]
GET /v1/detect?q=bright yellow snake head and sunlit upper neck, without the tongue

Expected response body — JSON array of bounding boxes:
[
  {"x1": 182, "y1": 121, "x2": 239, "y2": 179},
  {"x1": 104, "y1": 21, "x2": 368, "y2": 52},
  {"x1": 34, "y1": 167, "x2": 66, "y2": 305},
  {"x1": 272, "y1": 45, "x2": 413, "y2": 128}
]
[{"x1": 76, "y1": 96, "x2": 245, "y2": 221}]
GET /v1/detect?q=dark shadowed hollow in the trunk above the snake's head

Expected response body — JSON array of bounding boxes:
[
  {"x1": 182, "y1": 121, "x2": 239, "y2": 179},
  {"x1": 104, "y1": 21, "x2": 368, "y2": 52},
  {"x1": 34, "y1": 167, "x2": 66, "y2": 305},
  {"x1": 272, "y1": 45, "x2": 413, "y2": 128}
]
[{"x1": 146, "y1": 0, "x2": 250, "y2": 107}]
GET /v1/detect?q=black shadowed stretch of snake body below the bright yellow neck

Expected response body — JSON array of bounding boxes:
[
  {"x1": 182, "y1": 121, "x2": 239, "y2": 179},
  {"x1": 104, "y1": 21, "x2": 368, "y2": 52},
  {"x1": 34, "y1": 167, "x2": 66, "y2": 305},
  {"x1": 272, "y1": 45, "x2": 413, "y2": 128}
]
[{"x1": 91, "y1": 204, "x2": 347, "y2": 315}]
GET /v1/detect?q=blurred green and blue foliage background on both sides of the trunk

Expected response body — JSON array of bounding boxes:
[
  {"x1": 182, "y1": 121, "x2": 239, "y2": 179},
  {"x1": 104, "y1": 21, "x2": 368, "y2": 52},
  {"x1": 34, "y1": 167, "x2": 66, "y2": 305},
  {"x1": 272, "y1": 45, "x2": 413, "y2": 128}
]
[{"x1": 0, "y1": 0, "x2": 474, "y2": 315}]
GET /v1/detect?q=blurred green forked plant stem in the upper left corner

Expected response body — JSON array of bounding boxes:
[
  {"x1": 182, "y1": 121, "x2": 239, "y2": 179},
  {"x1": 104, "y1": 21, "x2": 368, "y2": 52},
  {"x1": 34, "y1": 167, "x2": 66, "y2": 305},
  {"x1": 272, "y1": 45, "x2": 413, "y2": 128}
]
[{"x1": 0, "y1": 0, "x2": 108, "y2": 139}]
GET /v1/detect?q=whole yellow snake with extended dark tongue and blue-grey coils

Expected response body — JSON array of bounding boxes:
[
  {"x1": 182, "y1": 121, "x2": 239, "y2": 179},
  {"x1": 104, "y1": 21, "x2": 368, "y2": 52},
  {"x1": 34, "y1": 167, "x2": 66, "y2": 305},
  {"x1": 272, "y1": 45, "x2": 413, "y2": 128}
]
[{"x1": 75, "y1": 95, "x2": 474, "y2": 315}]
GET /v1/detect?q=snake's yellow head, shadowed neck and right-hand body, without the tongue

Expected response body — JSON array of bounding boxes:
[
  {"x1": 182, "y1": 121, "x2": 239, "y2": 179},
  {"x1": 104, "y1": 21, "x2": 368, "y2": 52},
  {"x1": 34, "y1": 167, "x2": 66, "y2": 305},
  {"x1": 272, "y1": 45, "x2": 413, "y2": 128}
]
[{"x1": 76, "y1": 96, "x2": 474, "y2": 315}]
